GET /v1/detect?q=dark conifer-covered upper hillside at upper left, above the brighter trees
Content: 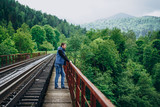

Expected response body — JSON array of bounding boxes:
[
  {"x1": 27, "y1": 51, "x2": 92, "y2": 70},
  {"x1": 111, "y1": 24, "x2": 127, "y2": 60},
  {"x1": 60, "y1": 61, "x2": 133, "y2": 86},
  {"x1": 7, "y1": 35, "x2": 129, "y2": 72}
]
[{"x1": 0, "y1": 0, "x2": 86, "y2": 37}]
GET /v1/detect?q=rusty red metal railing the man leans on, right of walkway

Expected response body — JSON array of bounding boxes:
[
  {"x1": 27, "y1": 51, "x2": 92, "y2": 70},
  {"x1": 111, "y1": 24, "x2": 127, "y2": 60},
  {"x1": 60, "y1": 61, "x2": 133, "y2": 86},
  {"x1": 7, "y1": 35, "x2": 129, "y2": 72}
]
[{"x1": 64, "y1": 62, "x2": 114, "y2": 107}]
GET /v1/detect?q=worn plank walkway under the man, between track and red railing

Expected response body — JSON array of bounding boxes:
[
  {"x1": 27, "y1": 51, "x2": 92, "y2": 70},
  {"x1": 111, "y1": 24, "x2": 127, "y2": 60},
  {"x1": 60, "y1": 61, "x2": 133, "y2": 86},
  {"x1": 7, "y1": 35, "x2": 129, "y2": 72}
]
[{"x1": 43, "y1": 68, "x2": 72, "y2": 107}]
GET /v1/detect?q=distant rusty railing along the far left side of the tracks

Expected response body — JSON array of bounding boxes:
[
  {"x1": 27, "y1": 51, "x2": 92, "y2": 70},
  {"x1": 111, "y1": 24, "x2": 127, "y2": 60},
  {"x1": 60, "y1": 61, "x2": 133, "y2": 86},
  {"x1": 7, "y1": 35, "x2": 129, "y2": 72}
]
[{"x1": 0, "y1": 52, "x2": 46, "y2": 67}]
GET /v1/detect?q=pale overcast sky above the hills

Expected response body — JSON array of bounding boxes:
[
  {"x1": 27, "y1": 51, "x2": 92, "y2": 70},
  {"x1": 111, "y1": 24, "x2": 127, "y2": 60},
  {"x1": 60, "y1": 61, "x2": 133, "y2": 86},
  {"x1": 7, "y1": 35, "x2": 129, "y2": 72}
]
[{"x1": 17, "y1": 0, "x2": 160, "y2": 24}]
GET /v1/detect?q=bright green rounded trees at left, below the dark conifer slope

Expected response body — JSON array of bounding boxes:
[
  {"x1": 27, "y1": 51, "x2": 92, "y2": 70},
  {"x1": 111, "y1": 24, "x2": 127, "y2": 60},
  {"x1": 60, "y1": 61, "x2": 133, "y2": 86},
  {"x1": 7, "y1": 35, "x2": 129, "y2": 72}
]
[{"x1": 0, "y1": 22, "x2": 64, "y2": 55}]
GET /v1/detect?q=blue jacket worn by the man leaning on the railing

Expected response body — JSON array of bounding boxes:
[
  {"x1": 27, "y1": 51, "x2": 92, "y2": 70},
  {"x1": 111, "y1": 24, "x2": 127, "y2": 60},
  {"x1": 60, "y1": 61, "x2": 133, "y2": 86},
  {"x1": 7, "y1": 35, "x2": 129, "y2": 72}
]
[{"x1": 55, "y1": 46, "x2": 66, "y2": 66}]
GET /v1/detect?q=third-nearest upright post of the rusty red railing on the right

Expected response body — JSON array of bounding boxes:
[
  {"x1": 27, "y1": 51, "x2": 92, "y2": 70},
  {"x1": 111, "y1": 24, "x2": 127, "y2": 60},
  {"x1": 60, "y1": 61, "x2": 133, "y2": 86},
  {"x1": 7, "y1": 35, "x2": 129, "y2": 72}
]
[{"x1": 76, "y1": 74, "x2": 80, "y2": 107}]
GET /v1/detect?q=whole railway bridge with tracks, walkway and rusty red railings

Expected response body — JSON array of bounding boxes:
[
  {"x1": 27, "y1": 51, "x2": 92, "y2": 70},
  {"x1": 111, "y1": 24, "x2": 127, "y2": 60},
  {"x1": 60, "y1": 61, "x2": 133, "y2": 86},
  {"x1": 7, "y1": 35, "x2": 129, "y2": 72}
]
[{"x1": 0, "y1": 52, "x2": 114, "y2": 107}]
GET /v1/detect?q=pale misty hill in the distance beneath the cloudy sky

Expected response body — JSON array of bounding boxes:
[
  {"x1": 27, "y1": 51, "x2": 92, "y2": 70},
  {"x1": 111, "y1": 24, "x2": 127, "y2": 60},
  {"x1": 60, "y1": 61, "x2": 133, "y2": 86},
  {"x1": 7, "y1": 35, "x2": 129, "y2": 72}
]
[{"x1": 81, "y1": 13, "x2": 160, "y2": 37}]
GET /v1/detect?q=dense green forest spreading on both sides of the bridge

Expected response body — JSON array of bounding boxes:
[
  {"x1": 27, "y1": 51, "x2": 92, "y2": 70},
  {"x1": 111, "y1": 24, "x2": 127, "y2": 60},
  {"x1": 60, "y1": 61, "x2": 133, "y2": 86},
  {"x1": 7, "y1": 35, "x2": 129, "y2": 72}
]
[{"x1": 0, "y1": 0, "x2": 160, "y2": 107}]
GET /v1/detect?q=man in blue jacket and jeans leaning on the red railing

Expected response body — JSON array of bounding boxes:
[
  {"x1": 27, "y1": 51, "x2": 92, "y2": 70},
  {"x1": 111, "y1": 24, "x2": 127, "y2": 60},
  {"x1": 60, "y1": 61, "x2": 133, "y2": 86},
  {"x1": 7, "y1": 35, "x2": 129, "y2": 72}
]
[{"x1": 55, "y1": 43, "x2": 70, "y2": 89}]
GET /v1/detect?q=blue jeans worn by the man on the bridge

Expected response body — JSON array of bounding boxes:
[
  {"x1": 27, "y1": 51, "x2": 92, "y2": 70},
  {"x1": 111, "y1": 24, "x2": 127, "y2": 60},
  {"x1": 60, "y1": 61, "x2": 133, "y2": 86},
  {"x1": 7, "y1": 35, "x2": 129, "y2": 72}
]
[{"x1": 55, "y1": 64, "x2": 65, "y2": 88}]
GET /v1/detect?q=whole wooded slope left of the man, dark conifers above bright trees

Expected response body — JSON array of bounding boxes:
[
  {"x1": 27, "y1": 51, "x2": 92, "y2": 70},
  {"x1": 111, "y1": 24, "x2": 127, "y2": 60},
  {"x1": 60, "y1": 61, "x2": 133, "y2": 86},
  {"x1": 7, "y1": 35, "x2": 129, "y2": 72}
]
[{"x1": 0, "y1": 0, "x2": 86, "y2": 55}]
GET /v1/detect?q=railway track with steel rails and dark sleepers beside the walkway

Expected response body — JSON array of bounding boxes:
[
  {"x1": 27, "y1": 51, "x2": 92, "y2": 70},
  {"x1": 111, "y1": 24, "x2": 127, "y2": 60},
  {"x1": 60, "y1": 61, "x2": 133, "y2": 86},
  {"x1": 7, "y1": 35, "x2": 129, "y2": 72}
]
[{"x1": 0, "y1": 54, "x2": 55, "y2": 107}]
